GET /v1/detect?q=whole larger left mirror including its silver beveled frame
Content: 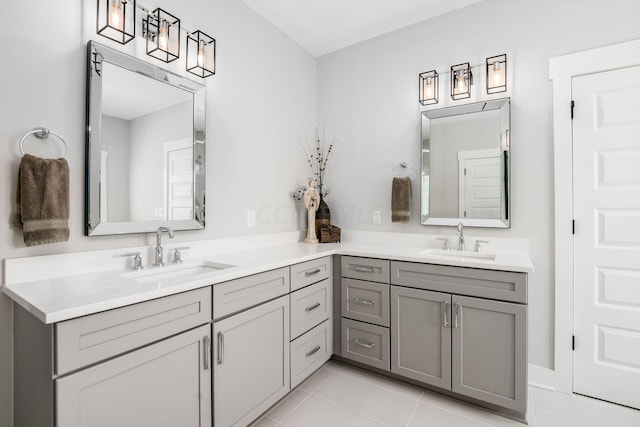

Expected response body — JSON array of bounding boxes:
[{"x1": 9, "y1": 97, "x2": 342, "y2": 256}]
[{"x1": 85, "y1": 41, "x2": 206, "y2": 236}]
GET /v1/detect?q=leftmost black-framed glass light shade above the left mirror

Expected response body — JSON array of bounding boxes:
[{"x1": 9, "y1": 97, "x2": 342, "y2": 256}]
[{"x1": 96, "y1": 0, "x2": 136, "y2": 44}]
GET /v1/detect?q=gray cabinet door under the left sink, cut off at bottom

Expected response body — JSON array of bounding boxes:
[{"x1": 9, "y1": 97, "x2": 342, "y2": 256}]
[{"x1": 55, "y1": 325, "x2": 211, "y2": 427}]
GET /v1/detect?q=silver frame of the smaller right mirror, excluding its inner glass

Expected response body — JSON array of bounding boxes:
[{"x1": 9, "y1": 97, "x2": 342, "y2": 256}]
[{"x1": 420, "y1": 98, "x2": 511, "y2": 228}]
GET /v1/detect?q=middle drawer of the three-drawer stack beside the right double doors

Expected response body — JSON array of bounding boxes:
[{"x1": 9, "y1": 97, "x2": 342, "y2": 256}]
[{"x1": 341, "y1": 279, "x2": 389, "y2": 327}]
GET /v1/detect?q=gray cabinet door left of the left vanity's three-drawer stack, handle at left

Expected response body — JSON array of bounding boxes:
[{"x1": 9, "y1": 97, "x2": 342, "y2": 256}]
[{"x1": 213, "y1": 295, "x2": 289, "y2": 427}]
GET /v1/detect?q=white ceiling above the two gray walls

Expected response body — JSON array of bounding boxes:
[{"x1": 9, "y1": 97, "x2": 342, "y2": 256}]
[{"x1": 242, "y1": 0, "x2": 483, "y2": 57}]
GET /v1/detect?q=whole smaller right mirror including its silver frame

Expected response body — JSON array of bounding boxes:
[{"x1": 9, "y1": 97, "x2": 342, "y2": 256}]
[{"x1": 420, "y1": 98, "x2": 511, "y2": 228}]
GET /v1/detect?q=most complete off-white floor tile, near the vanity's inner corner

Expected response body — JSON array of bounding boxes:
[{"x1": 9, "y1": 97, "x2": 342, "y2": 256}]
[{"x1": 314, "y1": 373, "x2": 418, "y2": 427}]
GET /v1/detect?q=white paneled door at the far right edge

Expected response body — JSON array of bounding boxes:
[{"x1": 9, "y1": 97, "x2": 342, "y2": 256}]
[{"x1": 572, "y1": 67, "x2": 640, "y2": 409}]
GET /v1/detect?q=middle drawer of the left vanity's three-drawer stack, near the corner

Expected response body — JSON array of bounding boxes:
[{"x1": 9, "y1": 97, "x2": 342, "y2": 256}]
[{"x1": 290, "y1": 279, "x2": 333, "y2": 338}]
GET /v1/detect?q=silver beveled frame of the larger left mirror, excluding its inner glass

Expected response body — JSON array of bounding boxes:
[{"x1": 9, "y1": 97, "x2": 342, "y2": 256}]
[{"x1": 85, "y1": 41, "x2": 206, "y2": 236}]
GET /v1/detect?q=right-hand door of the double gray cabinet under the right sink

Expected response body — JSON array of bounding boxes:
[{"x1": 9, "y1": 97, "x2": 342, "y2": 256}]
[{"x1": 451, "y1": 295, "x2": 527, "y2": 412}]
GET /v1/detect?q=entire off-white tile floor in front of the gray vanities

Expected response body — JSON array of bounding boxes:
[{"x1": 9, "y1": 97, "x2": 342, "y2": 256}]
[{"x1": 252, "y1": 361, "x2": 640, "y2": 427}]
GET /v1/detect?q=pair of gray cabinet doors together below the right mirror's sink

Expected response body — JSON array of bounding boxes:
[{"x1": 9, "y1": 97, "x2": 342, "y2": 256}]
[{"x1": 391, "y1": 286, "x2": 527, "y2": 413}]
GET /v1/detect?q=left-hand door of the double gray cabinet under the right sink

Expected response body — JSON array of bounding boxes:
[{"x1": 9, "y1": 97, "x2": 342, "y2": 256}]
[{"x1": 391, "y1": 286, "x2": 451, "y2": 389}]
